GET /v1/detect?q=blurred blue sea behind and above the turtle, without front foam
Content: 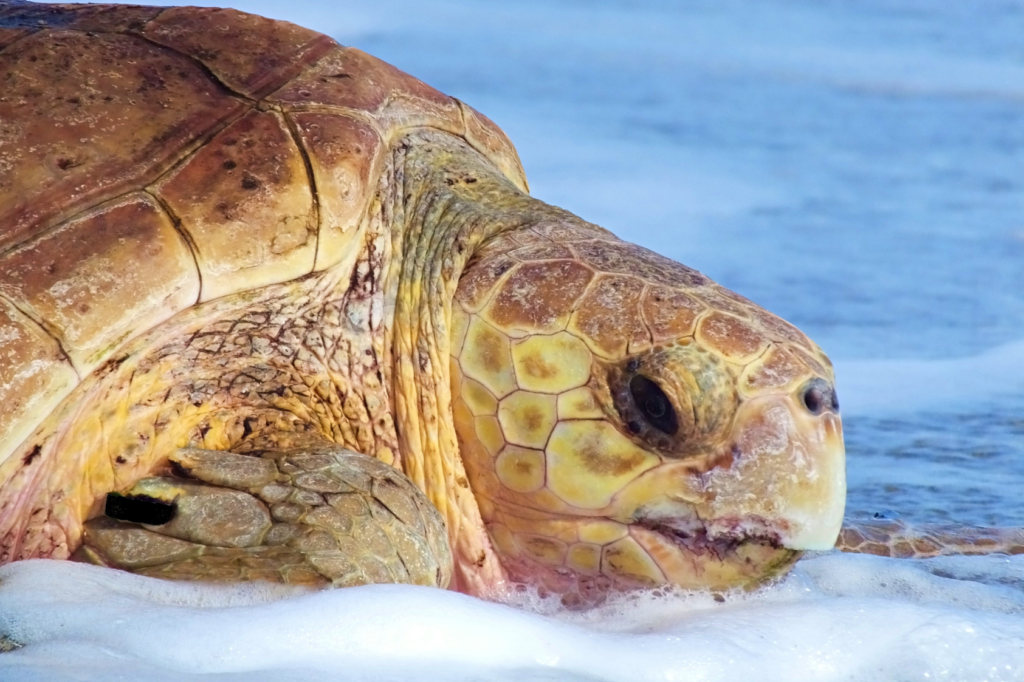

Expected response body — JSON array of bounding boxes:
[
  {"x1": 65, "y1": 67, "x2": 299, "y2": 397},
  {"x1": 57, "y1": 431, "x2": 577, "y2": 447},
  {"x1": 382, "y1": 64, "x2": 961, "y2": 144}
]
[{"x1": 83, "y1": 0, "x2": 1024, "y2": 525}]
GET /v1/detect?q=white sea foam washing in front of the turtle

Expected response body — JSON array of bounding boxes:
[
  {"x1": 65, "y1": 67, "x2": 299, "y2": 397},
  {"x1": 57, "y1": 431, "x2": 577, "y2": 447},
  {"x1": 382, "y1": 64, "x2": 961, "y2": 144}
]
[{"x1": 0, "y1": 555, "x2": 1024, "y2": 682}]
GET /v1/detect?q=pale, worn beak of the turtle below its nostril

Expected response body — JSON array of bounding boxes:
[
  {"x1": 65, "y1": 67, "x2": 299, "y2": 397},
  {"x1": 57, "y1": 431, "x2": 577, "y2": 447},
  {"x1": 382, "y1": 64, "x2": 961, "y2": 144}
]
[{"x1": 706, "y1": 387, "x2": 846, "y2": 550}]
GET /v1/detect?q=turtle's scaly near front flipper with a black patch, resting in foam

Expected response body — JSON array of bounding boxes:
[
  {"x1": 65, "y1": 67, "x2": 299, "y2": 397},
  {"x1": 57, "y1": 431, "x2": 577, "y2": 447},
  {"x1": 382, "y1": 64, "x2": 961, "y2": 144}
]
[{"x1": 77, "y1": 446, "x2": 452, "y2": 587}]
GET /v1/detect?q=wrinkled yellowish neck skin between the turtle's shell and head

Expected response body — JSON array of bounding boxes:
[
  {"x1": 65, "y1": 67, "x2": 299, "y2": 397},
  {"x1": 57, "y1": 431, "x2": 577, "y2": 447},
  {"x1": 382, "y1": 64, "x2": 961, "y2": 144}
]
[{"x1": 382, "y1": 131, "x2": 607, "y2": 596}]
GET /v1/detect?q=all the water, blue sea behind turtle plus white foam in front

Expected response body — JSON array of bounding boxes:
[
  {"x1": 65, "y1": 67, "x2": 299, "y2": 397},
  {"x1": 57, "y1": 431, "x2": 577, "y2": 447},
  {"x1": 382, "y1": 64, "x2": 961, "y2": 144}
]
[{"x1": 8, "y1": 0, "x2": 1024, "y2": 681}]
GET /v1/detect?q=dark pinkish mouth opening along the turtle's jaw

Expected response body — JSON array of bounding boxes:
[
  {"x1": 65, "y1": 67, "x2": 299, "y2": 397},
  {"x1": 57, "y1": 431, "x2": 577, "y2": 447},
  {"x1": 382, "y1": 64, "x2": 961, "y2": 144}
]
[{"x1": 635, "y1": 517, "x2": 793, "y2": 561}]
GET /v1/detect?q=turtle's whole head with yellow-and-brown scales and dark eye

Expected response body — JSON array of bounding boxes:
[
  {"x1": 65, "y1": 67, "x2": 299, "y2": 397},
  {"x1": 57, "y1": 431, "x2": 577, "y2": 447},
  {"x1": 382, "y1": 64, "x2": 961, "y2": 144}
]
[{"x1": 452, "y1": 227, "x2": 846, "y2": 598}]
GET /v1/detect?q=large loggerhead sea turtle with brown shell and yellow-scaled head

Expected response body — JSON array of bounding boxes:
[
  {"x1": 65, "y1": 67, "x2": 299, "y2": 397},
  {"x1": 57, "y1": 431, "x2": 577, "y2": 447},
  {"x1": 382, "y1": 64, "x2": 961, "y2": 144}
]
[{"x1": 0, "y1": 1, "x2": 1011, "y2": 599}]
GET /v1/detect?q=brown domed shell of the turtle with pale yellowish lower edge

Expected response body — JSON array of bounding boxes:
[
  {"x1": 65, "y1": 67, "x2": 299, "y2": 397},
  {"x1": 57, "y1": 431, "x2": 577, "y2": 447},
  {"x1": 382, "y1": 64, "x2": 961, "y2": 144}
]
[{"x1": 0, "y1": 1, "x2": 526, "y2": 462}]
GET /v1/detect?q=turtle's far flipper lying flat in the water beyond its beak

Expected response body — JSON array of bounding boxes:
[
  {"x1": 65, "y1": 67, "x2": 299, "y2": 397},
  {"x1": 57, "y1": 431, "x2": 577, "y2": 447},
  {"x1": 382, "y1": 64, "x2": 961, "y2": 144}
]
[{"x1": 836, "y1": 519, "x2": 1024, "y2": 559}]
